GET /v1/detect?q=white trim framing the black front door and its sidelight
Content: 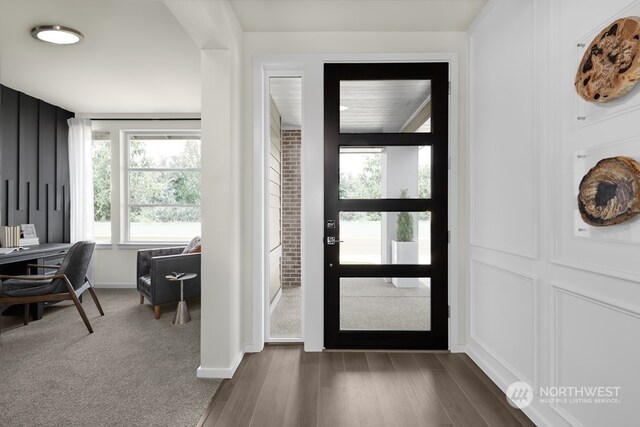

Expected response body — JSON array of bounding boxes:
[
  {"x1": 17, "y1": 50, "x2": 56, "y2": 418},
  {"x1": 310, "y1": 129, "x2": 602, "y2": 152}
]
[{"x1": 250, "y1": 52, "x2": 466, "y2": 352}]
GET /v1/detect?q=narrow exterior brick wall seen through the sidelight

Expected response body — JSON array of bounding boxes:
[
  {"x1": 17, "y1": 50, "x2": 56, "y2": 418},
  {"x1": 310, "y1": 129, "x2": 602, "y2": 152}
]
[{"x1": 281, "y1": 129, "x2": 302, "y2": 287}]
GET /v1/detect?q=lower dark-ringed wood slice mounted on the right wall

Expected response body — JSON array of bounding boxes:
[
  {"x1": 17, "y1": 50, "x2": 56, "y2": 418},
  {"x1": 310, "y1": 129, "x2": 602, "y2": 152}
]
[{"x1": 578, "y1": 157, "x2": 640, "y2": 226}]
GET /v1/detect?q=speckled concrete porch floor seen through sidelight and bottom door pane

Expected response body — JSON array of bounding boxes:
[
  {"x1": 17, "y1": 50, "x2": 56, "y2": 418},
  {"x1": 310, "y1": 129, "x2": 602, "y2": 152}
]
[{"x1": 270, "y1": 278, "x2": 431, "y2": 338}]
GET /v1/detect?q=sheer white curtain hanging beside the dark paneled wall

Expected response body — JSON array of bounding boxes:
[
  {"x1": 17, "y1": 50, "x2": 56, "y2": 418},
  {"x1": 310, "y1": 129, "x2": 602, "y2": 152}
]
[{"x1": 67, "y1": 118, "x2": 93, "y2": 243}]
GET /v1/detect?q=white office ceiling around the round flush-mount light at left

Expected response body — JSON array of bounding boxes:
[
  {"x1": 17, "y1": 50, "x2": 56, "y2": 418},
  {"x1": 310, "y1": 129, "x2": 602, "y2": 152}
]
[{"x1": 0, "y1": 0, "x2": 200, "y2": 113}]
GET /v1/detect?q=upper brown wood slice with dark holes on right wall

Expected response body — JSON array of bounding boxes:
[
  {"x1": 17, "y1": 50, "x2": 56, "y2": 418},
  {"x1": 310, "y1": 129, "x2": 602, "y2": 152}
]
[{"x1": 575, "y1": 16, "x2": 640, "y2": 103}]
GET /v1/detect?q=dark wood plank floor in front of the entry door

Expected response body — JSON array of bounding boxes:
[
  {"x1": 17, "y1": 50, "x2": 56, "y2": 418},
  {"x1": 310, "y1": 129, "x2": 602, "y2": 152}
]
[{"x1": 198, "y1": 345, "x2": 534, "y2": 427}]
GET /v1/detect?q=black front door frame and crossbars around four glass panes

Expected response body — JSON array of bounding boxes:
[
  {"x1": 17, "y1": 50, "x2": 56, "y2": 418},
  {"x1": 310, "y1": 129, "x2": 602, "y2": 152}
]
[{"x1": 324, "y1": 62, "x2": 449, "y2": 349}]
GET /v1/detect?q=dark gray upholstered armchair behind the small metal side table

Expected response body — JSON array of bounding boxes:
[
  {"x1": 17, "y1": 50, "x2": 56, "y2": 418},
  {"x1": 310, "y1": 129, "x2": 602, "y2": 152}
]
[{"x1": 136, "y1": 246, "x2": 200, "y2": 319}]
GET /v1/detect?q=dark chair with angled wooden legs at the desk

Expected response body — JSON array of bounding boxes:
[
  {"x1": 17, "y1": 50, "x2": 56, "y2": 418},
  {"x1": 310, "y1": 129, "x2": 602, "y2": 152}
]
[{"x1": 0, "y1": 241, "x2": 104, "y2": 333}]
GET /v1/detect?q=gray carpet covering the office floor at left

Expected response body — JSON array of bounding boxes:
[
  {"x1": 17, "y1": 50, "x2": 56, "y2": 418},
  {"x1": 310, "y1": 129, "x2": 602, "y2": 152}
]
[{"x1": 0, "y1": 289, "x2": 220, "y2": 427}]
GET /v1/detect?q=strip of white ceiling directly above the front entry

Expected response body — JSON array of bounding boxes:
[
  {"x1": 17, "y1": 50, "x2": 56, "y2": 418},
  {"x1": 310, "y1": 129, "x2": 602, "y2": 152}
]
[{"x1": 230, "y1": 0, "x2": 487, "y2": 31}]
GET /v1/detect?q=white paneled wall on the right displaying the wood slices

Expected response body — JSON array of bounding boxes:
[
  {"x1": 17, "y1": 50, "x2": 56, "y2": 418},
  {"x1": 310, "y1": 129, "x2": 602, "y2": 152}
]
[{"x1": 468, "y1": 0, "x2": 640, "y2": 426}]
